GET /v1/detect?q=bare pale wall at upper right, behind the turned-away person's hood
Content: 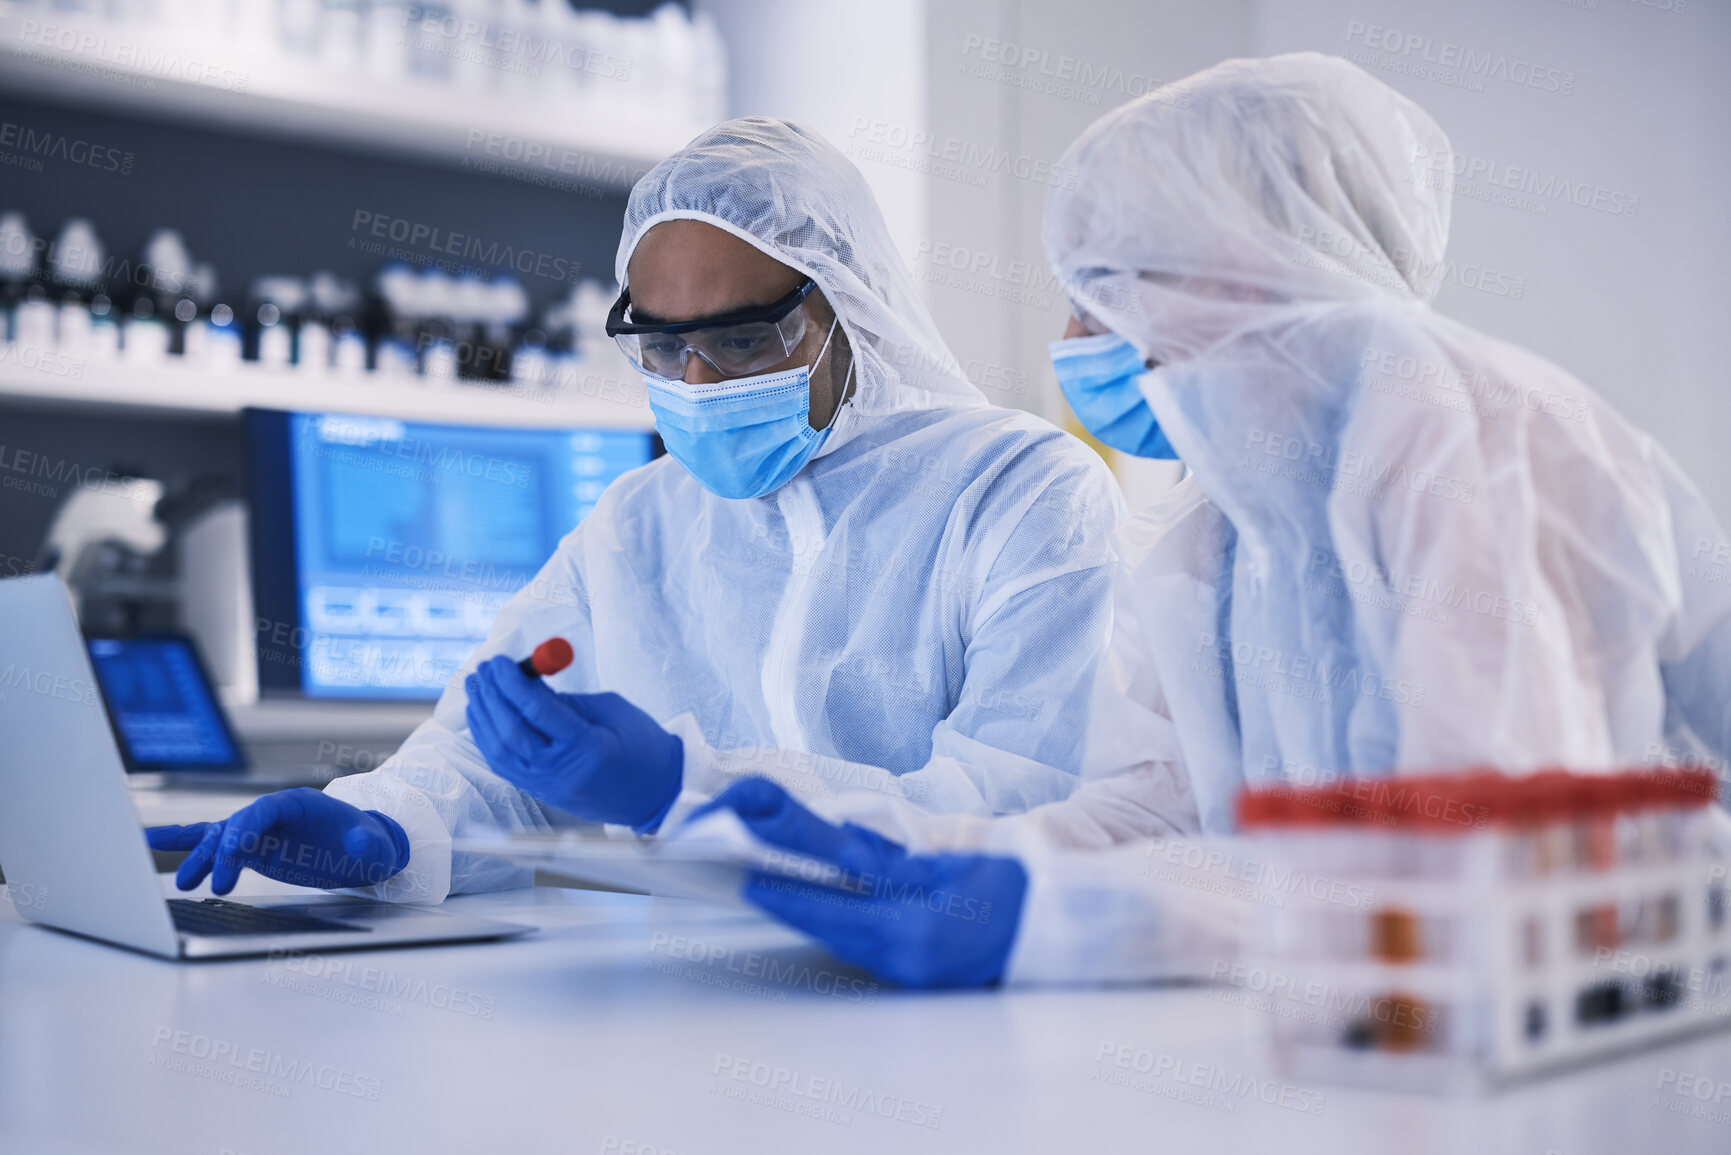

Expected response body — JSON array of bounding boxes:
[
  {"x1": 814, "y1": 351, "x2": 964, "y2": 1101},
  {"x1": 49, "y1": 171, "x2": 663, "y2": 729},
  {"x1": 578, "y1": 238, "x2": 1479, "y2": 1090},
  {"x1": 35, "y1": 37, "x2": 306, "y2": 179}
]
[{"x1": 1253, "y1": 0, "x2": 1731, "y2": 521}]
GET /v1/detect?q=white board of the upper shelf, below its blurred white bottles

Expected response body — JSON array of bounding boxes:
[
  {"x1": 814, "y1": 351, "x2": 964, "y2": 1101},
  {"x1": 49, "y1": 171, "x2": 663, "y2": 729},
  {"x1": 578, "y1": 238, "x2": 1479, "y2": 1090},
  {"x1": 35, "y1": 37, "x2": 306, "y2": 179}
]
[{"x1": 0, "y1": 0, "x2": 694, "y2": 188}]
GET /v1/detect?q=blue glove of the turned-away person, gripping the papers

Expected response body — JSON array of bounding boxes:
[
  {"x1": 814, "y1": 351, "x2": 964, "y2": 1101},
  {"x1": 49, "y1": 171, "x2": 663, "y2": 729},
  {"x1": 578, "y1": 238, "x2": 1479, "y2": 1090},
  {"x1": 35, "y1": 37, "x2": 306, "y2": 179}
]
[{"x1": 691, "y1": 778, "x2": 1028, "y2": 987}]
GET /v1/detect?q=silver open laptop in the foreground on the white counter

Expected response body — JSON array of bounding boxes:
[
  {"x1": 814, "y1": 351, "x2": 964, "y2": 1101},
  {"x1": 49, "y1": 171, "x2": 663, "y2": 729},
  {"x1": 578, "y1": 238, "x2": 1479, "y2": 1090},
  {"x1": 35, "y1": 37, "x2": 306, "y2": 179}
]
[{"x1": 0, "y1": 573, "x2": 533, "y2": 959}]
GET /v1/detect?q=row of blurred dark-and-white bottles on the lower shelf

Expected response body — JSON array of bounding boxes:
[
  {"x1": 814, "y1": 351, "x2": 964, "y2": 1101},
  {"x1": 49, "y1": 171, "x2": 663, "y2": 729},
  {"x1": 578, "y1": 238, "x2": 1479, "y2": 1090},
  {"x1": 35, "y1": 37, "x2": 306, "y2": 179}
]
[{"x1": 0, "y1": 211, "x2": 637, "y2": 391}]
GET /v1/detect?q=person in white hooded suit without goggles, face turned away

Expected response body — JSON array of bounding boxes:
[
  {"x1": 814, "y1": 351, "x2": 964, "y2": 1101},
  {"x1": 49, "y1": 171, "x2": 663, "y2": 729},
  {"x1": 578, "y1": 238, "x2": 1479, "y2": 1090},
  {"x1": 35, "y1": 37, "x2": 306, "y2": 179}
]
[{"x1": 695, "y1": 54, "x2": 1731, "y2": 985}]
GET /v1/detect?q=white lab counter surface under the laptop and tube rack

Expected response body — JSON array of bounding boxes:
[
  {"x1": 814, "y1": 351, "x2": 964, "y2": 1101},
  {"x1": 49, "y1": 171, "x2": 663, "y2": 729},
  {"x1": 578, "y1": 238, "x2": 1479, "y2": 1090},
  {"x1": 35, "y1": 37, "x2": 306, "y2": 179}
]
[{"x1": 0, "y1": 813, "x2": 1731, "y2": 1155}]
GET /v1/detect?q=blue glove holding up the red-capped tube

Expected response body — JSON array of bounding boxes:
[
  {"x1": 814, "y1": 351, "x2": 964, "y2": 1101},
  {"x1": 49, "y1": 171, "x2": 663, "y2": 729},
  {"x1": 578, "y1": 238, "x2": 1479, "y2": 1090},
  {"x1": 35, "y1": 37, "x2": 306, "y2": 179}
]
[{"x1": 464, "y1": 656, "x2": 685, "y2": 833}]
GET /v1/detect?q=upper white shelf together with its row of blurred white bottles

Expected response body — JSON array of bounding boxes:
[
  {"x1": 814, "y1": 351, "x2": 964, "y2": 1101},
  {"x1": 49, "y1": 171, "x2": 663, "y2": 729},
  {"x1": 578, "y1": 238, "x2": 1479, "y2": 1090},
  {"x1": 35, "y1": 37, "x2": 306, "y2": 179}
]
[{"x1": 0, "y1": 0, "x2": 727, "y2": 171}]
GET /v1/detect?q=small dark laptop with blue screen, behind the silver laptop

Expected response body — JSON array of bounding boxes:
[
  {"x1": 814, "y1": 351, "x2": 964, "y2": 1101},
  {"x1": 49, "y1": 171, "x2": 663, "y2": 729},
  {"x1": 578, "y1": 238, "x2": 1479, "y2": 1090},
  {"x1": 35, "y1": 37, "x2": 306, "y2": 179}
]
[{"x1": 85, "y1": 634, "x2": 341, "y2": 793}]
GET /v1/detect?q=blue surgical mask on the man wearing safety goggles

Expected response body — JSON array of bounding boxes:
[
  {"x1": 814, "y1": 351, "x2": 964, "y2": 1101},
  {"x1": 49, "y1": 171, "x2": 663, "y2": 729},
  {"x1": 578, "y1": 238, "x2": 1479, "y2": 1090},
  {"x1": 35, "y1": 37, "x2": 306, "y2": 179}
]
[{"x1": 644, "y1": 322, "x2": 841, "y2": 499}]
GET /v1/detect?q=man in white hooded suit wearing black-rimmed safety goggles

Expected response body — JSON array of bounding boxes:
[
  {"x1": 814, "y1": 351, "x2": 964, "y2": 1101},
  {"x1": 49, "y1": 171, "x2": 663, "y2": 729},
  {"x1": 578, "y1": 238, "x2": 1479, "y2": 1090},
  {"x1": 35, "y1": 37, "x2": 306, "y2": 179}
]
[{"x1": 149, "y1": 119, "x2": 1123, "y2": 902}]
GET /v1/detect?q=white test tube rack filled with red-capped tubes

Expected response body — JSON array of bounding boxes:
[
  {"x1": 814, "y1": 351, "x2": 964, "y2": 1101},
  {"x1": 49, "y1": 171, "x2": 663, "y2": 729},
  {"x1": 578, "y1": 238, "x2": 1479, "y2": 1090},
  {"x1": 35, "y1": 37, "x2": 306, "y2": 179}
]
[{"x1": 1238, "y1": 769, "x2": 1731, "y2": 1091}]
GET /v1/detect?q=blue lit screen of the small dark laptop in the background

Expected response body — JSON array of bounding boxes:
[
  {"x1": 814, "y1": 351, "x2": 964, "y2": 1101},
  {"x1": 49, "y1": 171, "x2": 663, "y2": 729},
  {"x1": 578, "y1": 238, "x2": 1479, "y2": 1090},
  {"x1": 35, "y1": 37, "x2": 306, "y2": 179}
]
[{"x1": 87, "y1": 634, "x2": 246, "y2": 771}]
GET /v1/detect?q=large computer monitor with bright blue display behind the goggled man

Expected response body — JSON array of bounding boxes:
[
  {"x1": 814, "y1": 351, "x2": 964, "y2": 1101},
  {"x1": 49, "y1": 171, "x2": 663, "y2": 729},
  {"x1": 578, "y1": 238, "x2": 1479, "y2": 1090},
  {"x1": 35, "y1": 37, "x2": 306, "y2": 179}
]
[{"x1": 246, "y1": 409, "x2": 660, "y2": 700}]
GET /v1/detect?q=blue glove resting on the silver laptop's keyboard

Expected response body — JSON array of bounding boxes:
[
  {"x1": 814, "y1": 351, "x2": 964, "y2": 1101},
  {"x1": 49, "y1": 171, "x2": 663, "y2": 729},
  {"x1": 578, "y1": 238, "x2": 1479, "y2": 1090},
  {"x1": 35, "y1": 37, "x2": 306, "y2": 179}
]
[{"x1": 144, "y1": 786, "x2": 409, "y2": 894}]
